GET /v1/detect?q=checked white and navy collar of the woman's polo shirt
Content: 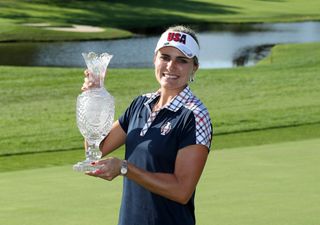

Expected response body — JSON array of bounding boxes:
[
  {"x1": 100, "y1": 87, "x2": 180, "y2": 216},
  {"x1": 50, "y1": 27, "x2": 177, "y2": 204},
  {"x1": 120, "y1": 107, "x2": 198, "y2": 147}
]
[{"x1": 144, "y1": 86, "x2": 193, "y2": 112}]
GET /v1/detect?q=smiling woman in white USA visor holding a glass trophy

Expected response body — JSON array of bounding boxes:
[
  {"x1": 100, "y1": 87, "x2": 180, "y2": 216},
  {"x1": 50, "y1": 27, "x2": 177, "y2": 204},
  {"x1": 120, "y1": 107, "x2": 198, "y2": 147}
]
[{"x1": 83, "y1": 26, "x2": 212, "y2": 225}]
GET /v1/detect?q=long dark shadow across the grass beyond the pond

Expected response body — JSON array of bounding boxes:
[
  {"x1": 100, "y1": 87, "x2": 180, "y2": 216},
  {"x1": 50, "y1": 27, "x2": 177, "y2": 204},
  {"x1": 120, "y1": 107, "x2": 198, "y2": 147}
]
[{"x1": 0, "y1": 0, "x2": 237, "y2": 30}]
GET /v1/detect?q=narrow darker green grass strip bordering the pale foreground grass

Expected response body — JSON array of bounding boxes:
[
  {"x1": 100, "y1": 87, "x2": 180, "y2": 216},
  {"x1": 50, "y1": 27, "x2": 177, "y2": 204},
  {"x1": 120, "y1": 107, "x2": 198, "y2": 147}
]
[{"x1": 0, "y1": 124, "x2": 320, "y2": 172}]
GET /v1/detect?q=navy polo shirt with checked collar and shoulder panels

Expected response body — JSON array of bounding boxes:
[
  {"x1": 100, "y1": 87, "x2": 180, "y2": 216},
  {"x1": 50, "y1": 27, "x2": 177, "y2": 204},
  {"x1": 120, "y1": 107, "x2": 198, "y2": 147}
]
[{"x1": 119, "y1": 87, "x2": 212, "y2": 225}]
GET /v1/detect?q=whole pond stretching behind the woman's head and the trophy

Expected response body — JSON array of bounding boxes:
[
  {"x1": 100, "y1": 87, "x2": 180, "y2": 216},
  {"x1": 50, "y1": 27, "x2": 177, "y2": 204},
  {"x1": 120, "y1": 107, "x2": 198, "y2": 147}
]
[{"x1": 0, "y1": 22, "x2": 320, "y2": 68}]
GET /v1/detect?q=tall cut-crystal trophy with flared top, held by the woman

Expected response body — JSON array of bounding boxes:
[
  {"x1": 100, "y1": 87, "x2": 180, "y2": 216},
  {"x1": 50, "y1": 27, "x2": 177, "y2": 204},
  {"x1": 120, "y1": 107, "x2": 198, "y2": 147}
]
[{"x1": 73, "y1": 52, "x2": 115, "y2": 172}]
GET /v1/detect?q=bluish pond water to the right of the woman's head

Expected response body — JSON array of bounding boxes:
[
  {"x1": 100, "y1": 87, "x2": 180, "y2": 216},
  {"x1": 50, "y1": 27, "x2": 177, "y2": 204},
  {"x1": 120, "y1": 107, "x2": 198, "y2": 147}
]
[{"x1": 199, "y1": 22, "x2": 320, "y2": 68}]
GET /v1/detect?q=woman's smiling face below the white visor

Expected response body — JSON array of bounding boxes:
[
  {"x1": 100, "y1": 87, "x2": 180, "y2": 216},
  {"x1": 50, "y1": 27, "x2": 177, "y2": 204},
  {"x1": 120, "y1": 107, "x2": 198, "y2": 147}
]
[{"x1": 154, "y1": 47, "x2": 198, "y2": 93}]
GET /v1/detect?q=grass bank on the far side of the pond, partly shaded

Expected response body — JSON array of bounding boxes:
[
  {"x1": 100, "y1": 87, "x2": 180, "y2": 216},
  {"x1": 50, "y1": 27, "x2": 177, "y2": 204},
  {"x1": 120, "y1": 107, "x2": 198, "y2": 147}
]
[{"x1": 0, "y1": 0, "x2": 320, "y2": 41}]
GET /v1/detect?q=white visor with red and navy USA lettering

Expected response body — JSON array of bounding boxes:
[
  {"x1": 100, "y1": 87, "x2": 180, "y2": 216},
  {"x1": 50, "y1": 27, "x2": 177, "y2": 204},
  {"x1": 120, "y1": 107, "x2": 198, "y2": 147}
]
[{"x1": 154, "y1": 30, "x2": 200, "y2": 59}]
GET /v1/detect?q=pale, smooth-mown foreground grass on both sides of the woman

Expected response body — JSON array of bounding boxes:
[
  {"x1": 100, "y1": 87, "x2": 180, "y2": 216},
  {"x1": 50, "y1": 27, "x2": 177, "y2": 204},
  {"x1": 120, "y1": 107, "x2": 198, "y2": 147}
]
[{"x1": 0, "y1": 139, "x2": 320, "y2": 225}]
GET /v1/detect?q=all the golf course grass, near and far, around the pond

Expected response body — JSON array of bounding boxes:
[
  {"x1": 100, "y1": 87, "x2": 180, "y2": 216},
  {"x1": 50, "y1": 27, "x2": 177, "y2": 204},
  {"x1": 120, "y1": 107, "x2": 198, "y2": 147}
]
[{"x1": 0, "y1": 0, "x2": 320, "y2": 225}]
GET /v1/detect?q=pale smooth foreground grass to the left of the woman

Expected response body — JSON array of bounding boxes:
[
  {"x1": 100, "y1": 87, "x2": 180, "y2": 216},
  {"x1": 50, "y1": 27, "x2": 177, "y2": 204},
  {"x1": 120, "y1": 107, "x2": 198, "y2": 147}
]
[{"x1": 0, "y1": 165, "x2": 121, "y2": 225}]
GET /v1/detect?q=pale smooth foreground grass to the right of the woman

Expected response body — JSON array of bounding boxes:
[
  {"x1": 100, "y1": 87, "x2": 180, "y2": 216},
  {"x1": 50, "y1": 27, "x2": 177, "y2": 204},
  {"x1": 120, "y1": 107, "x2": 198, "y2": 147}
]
[{"x1": 196, "y1": 139, "x2": 320, "y2": 225}]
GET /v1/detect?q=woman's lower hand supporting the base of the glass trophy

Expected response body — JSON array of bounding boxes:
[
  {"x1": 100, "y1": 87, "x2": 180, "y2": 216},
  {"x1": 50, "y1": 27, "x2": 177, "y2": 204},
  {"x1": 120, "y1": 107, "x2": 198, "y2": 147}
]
[{"x1": 86, "y1": 157, "x2": 122, "y2": 181}]
